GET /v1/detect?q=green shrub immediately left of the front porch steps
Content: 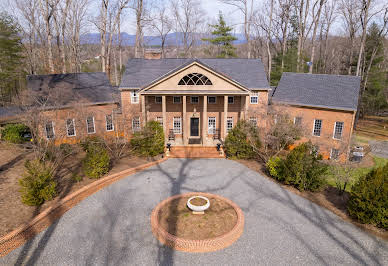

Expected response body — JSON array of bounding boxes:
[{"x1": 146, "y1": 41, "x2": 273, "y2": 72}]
[{"x1": 131, "y1": 121, "x2": 164, "y2": 157}]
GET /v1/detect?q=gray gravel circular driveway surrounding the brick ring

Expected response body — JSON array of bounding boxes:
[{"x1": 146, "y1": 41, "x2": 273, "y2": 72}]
[{"x1": 0, "y1": 159, "x2": 388, "y2": 265}]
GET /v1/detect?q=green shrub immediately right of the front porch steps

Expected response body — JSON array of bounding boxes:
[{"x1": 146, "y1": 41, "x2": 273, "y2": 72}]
[{"x1": 224, "y1": 120, "x2": 261, "y2": 159}]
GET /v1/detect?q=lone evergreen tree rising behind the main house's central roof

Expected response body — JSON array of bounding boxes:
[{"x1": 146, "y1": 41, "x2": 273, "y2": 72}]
[{"x1": 202, "y1": 12, "x2": 237, "y2": 58}]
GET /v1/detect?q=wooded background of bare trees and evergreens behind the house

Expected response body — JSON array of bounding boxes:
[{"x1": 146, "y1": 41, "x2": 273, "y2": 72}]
[{"x1": 0, "y1": 0, "x2": 388, "y2": 114}]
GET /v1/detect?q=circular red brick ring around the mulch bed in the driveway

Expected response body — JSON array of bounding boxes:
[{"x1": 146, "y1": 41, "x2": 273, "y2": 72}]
[{"x1": 151, "y1": 192, "x2": 244, "y2": 252}]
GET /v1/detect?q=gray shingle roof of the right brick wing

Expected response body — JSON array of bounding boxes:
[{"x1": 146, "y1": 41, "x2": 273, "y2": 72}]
[{"x1": 272, "y1": 72, "x2": 360, "y2": 110}]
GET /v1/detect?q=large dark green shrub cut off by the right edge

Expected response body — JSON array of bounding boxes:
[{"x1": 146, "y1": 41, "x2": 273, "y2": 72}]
[{"x1": 348, "y1": 163, "x2": 388, "y2": 229}]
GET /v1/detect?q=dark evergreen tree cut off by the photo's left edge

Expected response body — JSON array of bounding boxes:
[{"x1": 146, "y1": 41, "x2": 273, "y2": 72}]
[{"x1": 0, "y1": 13, "x2": 23, "y2": 105}]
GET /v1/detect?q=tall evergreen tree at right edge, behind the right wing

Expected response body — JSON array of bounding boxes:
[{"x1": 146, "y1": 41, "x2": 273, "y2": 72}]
[{"x1": 362, "y1": 23, "x2": 388, "y2": 114}]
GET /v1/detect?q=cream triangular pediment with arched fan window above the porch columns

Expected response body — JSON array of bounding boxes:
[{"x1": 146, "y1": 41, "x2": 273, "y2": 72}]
[{"x1": 140, "y1": 61, "x2": 249, "y2": 94}]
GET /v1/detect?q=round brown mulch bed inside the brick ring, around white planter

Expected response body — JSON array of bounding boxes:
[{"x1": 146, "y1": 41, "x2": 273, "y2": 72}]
[{"x1": 158, "y1": 197, "x2": 237, "y2": 240}]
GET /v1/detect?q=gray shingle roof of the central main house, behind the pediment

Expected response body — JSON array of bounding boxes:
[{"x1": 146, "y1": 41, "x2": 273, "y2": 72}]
[{"x1": 120, "y1": 58, "x2": 269, "y2": 89}]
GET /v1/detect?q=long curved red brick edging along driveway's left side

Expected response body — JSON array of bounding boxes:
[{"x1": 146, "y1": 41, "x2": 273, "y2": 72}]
[{"x1": 0, "y1": 157, "x2": 167, "y2": 257}]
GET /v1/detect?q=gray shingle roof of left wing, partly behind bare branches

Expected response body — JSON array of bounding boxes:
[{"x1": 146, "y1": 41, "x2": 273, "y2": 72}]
[{"x1": 27, "y1": 72, "x2": 118, "y2": 105}]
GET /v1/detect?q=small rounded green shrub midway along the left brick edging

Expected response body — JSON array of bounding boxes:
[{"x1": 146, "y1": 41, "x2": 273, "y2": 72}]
[{"x1": 82, "y1": 147, "x2": 110, "y2": 178}]
